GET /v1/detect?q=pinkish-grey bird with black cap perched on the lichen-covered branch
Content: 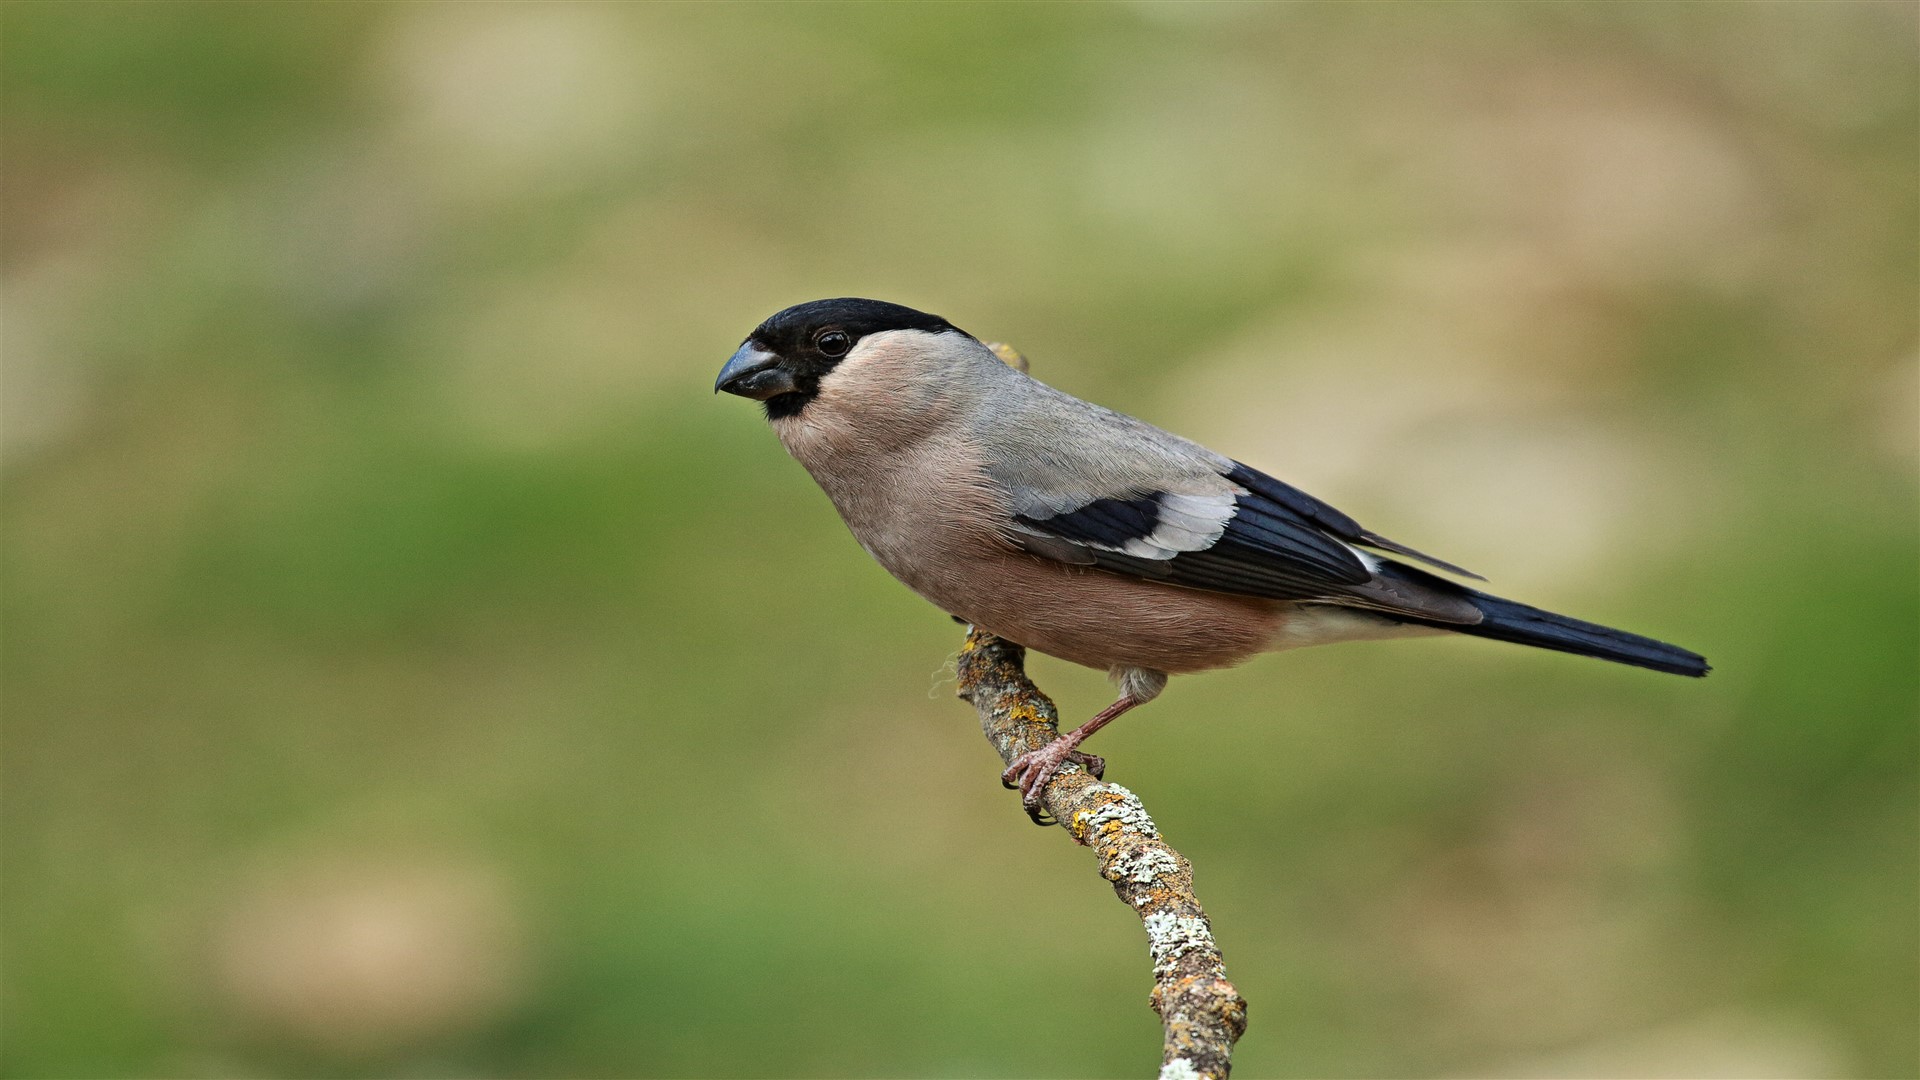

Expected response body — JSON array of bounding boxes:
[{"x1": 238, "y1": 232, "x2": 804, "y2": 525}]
[{"x1": 714, "y1": 296, "x2": 1709, "y2": 822}]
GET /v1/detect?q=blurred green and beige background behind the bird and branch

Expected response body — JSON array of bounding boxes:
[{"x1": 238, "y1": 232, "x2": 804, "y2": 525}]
[{"x1": 0, "y1": 2, "x2": 1920, "y2": 1076}]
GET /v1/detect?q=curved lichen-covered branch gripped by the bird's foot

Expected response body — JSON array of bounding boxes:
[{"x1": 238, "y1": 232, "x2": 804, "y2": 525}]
[{"x1": 958, "y1": 630, "x2": 1246, "y2": 1080}]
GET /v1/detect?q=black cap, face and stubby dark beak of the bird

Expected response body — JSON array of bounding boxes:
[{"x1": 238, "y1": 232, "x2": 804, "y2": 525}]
[{"x1": 714, "y1": 296, "x2": 977, "y2": 421}]
